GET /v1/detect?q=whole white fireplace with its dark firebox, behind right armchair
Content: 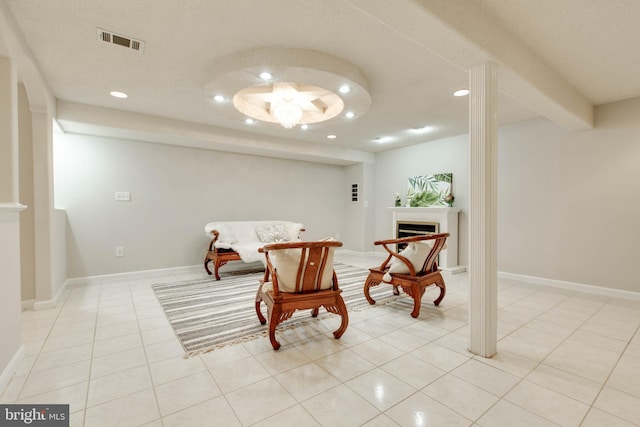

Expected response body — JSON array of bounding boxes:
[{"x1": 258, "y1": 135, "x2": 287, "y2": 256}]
[{"x1": 388, "y1": 207, "x2": 466, "y2": 273}]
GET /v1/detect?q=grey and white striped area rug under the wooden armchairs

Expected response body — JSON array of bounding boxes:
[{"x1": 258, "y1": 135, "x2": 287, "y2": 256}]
[{"x1": 151, "y1": 264, "x2": 397, "y2": 355}]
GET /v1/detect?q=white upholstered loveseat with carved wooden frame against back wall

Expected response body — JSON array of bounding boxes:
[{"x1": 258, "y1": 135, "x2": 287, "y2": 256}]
[{"x1": 204, "y1": 220, "x2": 304, "y2": 280}]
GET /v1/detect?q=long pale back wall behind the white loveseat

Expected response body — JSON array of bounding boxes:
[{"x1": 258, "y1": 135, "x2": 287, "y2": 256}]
[{"x1": 54, "y1": 134, "x2": 349, "y2": 277}]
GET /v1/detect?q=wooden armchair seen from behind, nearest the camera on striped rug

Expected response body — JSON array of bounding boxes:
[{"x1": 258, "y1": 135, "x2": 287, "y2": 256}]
[{"x1": 256, "y1": 240, "x2": 349, "y2": 350}]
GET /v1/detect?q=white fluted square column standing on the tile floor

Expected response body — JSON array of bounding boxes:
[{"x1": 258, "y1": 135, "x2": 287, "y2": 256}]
[{"x1": 469, "y1": 63, "x2": 498, "y2": 357}]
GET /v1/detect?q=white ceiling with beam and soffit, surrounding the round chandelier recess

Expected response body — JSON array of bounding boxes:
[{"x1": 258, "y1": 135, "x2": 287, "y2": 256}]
[{"x1": 0, "y1": 0, "x2": 640, "y2": 164}]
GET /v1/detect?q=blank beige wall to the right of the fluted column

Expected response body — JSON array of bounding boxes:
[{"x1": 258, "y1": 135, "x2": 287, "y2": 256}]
[{"x1": 498, "y1": 98, "x2": 640, "y2": 292}]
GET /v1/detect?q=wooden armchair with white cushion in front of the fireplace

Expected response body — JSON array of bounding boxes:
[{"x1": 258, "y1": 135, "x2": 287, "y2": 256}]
[{"x1": 364, "y1": 233, "x2": 449, "y2": 317}]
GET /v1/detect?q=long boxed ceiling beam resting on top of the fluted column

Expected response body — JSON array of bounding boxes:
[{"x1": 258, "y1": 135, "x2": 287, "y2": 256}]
[{"x1": 348, "y1": 0, "x2": 594, "y2": 130}]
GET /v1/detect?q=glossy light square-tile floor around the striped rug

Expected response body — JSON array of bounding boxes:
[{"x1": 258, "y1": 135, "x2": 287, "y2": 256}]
[{"x1": 0, "y1": 254, "x2": 640, "y2": 427}]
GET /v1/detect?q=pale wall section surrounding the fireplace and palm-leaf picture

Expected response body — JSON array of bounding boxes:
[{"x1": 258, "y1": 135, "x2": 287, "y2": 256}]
[{"x1": 374, "y1": 135, "x2": 469, "y2": 265}]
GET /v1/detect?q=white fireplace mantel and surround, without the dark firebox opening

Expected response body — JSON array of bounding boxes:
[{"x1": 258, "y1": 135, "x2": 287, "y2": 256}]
[{"x1": 388, "y1": 207, "x2": 466, "y2": 274}]
